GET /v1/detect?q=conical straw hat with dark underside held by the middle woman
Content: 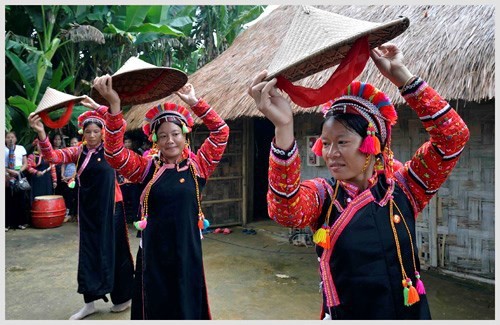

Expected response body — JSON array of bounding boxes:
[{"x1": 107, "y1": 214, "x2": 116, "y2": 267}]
[{"x1": 90, "y1": 56, "x2": 188, "y2": 106}]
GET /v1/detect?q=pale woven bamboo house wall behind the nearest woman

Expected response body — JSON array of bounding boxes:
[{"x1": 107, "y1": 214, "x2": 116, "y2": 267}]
[{"x1": 295, "y1": 101, "x2": 495, "y2": 279}]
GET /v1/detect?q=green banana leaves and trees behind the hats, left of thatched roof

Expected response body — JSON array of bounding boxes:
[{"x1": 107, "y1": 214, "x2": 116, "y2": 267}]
[{"x1": 5, "y1": 5, "x2": 270, "y2": 144}]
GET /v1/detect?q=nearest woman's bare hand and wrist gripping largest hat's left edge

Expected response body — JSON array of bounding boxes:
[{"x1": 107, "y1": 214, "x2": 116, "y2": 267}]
[{"x1": 248, "y1": 70, "x2": 294, "y2": 149}]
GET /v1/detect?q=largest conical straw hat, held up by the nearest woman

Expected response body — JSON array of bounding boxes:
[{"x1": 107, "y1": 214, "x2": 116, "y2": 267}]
[{"x1": 266, "y1": 6, "x2": 410, "y2": 82}]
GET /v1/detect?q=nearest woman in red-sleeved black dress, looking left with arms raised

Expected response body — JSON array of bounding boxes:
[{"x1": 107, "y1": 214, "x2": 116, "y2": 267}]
[{"x1": 249, "y1": 44, "x2": 469, "y2": 319}]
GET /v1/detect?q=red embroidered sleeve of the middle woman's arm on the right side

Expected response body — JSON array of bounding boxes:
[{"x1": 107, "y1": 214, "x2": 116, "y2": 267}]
[{"x1": 191, "y1": 99, "x2": 229, "y2": 179}]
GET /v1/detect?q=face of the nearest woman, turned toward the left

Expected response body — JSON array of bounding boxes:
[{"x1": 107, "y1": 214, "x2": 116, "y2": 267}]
[{"x1": 321, "y1": 118, "x2": 366, "y2": 187}]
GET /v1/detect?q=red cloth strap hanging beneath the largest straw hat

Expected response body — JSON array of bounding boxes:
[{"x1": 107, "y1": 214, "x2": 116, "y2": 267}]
[{"x1": 276, "y1": 36, "x2": 370, "y2": 107}]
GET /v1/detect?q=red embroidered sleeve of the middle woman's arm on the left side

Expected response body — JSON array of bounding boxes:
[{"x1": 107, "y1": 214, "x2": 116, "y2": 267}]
[{"x1": 104, "y1": 111, "x2": 152, "y2": 183}]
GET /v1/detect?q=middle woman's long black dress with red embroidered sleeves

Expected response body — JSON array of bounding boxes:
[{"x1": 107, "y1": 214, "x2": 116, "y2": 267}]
[{"x1": 105, "y1": 100, "x2": 229, "y2": 320}]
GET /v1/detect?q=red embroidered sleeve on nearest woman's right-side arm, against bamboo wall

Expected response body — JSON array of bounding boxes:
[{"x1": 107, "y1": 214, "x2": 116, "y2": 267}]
[{"x1": 396, "y1": 78, "x2": 469, "y2": 212}]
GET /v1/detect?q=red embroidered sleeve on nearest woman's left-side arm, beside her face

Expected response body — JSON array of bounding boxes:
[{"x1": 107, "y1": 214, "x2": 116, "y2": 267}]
[{"x1": 267, "y1": 143, "x2": 333, "y2": 230}]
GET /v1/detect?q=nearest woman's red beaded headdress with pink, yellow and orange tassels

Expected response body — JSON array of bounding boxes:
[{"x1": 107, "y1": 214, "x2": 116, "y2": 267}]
[{"x1": 313, "y1": 81, "x2": 425, "y2": 306}]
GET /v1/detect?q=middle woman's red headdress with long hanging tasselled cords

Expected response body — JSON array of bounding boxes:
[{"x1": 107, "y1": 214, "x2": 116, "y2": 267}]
[{"x1": 134, "y1": 102, "x2": 210, "y2": 233}]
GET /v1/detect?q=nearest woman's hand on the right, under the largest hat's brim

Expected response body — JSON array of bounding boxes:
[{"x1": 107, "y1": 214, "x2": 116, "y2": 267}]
[{"x1": 370, "y1": 43, "x2": 413, "y2": 87}]
